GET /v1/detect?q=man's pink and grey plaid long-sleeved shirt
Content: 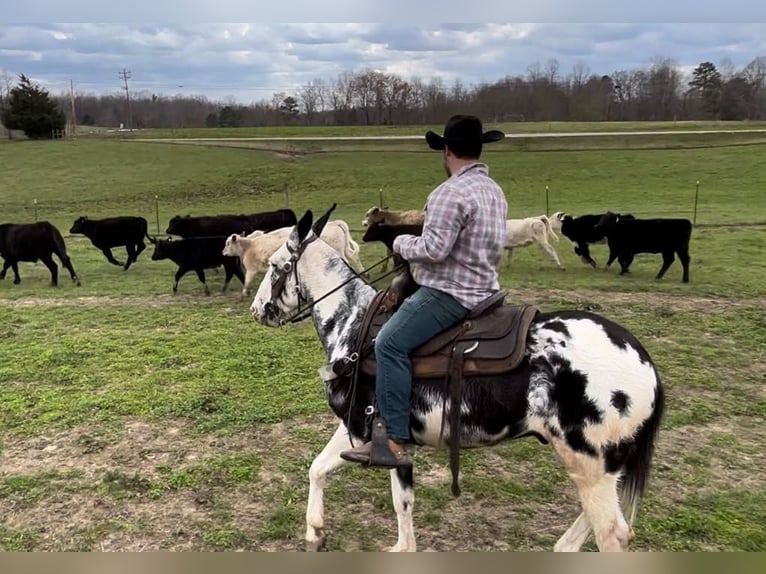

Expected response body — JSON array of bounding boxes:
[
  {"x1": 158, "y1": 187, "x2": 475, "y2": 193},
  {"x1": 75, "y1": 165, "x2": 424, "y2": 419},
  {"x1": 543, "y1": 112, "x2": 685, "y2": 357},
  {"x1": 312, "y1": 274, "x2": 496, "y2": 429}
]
[{"x1": 393, "y1": 162, "x2": 508, "y2": 309}]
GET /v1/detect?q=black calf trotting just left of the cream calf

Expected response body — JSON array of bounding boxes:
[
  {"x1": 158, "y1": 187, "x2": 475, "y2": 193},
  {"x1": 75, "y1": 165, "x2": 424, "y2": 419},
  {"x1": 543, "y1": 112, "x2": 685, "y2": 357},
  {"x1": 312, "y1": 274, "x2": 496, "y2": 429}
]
[{"x1": 149, "y1": 235, "x2": 245, "y2": 295}]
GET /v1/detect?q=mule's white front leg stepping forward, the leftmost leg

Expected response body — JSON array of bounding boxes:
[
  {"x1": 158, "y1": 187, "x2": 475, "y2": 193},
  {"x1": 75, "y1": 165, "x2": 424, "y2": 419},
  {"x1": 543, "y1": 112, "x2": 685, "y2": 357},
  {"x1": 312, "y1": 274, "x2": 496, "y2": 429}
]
[{"x1": 306, "y1": 423, "x2": 349, "y2": 550}]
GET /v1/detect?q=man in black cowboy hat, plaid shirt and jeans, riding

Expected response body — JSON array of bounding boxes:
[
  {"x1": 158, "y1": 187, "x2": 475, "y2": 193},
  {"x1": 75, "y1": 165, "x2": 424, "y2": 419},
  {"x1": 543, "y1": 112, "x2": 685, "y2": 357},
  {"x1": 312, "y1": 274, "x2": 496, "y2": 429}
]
[{"x1": 340, "y1": 115, "x2": 508, "y2": 468}]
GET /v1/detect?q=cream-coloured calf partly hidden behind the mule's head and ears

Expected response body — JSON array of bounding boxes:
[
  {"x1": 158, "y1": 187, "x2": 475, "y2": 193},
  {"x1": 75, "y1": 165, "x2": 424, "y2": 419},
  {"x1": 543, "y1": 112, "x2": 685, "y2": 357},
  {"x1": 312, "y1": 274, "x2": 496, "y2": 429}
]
[{"x1": 223, "y1": 219, "x2": 364, "y2": 296}]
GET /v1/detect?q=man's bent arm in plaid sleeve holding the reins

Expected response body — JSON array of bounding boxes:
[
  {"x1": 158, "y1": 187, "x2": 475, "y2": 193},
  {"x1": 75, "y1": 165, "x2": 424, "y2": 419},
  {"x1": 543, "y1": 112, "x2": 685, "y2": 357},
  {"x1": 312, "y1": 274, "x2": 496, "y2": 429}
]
[{"x1": 393, "y1": 189, "x2": 467, "y2": 263}]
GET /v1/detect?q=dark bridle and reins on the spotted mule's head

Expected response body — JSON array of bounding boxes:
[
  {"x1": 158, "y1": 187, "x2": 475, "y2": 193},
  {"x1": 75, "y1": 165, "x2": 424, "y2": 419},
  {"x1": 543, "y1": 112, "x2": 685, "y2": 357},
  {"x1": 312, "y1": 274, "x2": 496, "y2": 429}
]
[{"x1": 265, "y1": 234, "x2": 402, "y2": 326}]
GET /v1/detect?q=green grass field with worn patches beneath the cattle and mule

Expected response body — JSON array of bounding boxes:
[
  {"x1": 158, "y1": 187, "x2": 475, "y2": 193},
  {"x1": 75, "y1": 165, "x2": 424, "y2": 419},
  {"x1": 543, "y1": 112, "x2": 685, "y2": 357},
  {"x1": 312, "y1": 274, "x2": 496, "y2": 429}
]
[{"x1": 0, "y1": 124, "x2": 766, "y2": 551}]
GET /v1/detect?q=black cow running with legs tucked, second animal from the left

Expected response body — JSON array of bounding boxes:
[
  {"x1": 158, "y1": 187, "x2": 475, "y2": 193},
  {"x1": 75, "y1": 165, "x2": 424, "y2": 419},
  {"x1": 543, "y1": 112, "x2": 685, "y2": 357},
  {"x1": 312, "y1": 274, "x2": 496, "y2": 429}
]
[{"x1": 69, "y1": 216, "x2": 149, "y2": 271}]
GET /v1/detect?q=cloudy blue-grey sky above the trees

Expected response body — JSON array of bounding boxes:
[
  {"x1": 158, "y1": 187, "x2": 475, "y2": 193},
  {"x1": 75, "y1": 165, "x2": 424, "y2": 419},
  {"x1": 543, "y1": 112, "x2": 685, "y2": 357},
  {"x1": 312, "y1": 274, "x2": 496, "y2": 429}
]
[{"x1": 0, "y1": 23, "x2": 766, "y2": 103}]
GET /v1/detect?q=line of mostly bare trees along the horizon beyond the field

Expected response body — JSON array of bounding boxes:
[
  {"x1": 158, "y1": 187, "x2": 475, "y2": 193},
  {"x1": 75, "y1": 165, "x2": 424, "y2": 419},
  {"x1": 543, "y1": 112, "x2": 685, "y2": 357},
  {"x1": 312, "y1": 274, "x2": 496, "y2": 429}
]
[{"x1": 0, "y1": 56, "x2": 766, "y2": 138}]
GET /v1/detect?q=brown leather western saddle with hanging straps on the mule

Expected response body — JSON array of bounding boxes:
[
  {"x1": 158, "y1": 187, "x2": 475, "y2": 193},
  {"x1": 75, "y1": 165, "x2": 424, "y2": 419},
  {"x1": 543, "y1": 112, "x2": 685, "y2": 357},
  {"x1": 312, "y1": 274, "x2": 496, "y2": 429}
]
[{"x1": 349, "y1": 274, "x2": 539, "y2": 496}]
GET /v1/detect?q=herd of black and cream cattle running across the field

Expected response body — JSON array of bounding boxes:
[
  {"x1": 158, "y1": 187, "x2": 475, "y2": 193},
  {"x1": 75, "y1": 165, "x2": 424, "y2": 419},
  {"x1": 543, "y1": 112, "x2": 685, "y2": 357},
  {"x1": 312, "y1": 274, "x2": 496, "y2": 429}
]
[{"x1": 0, "y1": 207, "x2": 692, "y2": 296}]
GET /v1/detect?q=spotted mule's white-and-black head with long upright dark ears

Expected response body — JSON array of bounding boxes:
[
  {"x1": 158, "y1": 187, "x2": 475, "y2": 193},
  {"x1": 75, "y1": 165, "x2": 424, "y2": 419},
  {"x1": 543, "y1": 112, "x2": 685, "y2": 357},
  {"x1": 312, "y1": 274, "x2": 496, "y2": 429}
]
[{"x1": 250, "y1": 204, "x2": 335, "y2": 327}]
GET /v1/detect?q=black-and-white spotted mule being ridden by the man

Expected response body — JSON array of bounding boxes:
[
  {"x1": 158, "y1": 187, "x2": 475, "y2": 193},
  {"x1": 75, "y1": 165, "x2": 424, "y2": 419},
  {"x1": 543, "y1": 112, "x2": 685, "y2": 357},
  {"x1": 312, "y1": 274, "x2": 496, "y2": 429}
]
[{"x1": 251, "y1": 132, "x2": 664, "y2": 551}]
